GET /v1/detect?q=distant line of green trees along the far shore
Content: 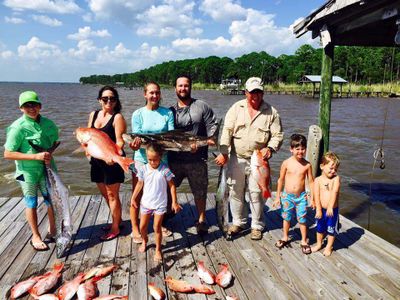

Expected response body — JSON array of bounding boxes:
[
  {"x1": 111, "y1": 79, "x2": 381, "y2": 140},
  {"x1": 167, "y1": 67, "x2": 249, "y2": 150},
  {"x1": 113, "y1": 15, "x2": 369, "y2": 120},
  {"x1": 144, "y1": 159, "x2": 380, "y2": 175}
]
[{"x1": 79, "y1": 45, "x2": 400, "y2": 86}]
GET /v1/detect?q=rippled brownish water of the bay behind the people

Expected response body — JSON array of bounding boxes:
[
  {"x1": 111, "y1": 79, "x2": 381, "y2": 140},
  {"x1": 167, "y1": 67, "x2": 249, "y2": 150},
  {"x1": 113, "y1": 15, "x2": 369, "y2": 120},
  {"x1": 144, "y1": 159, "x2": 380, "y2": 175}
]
[{"x1": 0, "y1": 83, "x2": 400, "y2": 246}]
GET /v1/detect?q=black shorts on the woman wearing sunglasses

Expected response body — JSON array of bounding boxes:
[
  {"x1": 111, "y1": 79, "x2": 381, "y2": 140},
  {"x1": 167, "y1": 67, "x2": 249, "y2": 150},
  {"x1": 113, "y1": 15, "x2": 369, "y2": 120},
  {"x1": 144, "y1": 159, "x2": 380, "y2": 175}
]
[{"x1": 90, "y1": 157, "x2": 125, "y2": 185}]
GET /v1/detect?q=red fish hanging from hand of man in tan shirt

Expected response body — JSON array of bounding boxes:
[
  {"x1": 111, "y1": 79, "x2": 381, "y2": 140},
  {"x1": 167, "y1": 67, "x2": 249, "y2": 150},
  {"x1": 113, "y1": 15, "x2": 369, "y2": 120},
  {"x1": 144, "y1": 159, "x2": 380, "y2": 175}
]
[{"x1": 250, "y1": 150, "x2": 271, "y2": 199}]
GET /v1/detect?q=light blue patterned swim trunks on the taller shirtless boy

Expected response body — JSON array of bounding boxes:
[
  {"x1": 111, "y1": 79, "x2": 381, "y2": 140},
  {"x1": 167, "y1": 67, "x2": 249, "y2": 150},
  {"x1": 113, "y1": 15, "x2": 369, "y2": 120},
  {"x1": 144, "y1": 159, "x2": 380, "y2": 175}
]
[{"x1": 281, "y1": 192, "x2": 307, "y2": 224}]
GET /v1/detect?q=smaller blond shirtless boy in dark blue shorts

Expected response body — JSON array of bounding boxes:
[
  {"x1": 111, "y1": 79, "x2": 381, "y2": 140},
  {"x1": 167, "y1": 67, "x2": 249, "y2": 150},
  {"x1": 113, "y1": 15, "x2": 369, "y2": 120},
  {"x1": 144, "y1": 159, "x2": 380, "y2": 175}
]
[{"x1": 311, "y1": 152, "x2": 340, "y2": 256}]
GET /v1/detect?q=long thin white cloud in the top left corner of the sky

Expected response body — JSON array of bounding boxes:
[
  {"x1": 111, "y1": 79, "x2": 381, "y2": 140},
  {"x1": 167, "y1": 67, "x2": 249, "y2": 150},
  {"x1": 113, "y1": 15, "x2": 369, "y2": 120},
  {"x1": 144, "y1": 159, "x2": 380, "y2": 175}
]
[{"x1": 3, "y1": 0, "x2": 81, "y2": 14}]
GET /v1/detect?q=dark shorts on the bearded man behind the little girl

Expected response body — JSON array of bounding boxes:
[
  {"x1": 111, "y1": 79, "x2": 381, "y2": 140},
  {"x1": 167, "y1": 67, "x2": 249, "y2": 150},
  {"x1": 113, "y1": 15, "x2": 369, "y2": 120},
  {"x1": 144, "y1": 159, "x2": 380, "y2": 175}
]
[{"x1": 169, "y1": 161, "x2": 208, "y2": 200}]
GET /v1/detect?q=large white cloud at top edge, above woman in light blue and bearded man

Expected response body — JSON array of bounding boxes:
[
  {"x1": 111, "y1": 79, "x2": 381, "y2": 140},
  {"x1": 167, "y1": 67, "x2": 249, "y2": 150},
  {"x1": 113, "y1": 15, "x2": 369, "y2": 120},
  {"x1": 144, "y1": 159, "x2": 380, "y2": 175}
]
[{"x1": 136, "y1": 0, "x2": 203, "y2": 38}]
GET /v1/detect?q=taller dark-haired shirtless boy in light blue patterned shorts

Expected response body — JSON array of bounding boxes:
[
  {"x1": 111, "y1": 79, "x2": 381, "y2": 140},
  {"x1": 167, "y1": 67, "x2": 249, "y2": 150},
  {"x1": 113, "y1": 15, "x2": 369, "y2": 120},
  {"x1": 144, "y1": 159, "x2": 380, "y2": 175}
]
[{"x1": 273, "y1": 134, "x2": 314, "y2": 254}]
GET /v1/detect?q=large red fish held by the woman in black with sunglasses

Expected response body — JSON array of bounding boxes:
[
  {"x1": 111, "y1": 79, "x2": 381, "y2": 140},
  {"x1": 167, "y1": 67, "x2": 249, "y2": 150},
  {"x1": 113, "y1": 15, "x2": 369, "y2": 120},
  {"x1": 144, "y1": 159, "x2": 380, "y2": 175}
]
[{"x1": 75, "y1": 128, "x2": 133, "y2": 173}]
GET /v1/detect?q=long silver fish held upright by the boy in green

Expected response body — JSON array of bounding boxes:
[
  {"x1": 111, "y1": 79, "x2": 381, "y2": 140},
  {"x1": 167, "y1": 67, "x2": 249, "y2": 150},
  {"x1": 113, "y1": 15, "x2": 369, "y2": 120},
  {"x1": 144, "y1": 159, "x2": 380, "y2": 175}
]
[{"x1": 29, "y1": 142, "x2": 72, "y2": 258}]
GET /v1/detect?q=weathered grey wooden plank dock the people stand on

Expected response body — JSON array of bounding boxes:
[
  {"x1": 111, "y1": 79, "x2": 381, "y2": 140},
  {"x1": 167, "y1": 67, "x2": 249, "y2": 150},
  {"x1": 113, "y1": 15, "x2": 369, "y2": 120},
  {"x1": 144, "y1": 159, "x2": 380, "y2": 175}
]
[{"x1": 0, "y1": 194, "x2": 400, "y2": 300}]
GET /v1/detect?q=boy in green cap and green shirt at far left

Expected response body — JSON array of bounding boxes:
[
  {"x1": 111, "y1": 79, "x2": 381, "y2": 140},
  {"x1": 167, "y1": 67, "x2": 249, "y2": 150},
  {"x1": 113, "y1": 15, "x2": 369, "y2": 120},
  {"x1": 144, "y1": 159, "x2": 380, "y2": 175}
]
[{"x1": 4, "y1": 91, "x2": 58, "y2": 251}]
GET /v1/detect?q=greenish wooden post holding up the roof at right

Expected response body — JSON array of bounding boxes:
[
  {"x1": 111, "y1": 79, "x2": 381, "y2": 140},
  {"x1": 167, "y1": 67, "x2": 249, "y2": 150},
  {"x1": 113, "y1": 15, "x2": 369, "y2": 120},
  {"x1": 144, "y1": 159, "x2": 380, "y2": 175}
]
[{"x1": 319, "y1": 43, "x2": 334, "y2": 154}]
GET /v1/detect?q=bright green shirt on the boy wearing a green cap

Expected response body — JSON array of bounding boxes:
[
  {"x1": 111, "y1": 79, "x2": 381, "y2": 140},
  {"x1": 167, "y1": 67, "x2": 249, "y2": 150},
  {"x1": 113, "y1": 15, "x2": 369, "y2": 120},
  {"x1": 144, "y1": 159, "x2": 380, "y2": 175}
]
[{"x1": 4, "y1": 115, "x2": 58, "y2": 183}]
